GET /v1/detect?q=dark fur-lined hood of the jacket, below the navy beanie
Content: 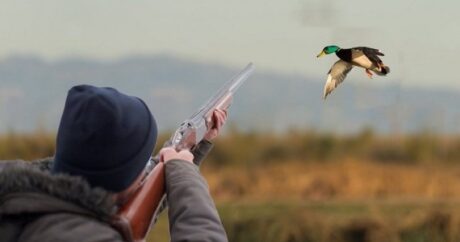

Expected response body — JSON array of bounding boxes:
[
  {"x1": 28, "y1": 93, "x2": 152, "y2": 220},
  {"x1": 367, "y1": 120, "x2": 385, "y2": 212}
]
[{"x1": 0, "y1": 158, "x2": 116, "y2": 221}]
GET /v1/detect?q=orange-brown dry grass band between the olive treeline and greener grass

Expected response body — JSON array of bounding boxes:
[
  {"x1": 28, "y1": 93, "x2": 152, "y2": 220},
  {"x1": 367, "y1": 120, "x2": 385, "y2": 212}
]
[{"x1": 203, "y1": 160, "x2": 460, "y2": 201}]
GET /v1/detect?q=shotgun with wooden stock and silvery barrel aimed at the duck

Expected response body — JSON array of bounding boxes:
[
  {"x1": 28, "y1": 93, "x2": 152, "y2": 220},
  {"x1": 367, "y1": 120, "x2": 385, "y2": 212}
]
[{"x1": 112, "y1": 63, "x2": 254, "y2": 242}]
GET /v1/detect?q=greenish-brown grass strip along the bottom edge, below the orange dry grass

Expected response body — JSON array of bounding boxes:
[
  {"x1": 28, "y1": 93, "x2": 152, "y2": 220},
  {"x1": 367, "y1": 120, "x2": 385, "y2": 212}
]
[{"x1": 148, "y1": 200, "x2": 460, "y2": 242}]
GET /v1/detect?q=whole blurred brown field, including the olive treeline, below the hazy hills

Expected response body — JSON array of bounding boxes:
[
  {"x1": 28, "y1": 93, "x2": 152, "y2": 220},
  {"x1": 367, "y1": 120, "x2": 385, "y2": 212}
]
[{"x1": 0, "y1": 129, "x2": 460, "y2": 242}]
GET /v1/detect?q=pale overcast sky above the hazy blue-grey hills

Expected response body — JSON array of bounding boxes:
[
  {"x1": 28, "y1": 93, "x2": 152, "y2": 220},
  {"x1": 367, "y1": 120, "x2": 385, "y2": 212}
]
[{"x1": 0, "y1": 0, "x2": 460, "y2": 90}]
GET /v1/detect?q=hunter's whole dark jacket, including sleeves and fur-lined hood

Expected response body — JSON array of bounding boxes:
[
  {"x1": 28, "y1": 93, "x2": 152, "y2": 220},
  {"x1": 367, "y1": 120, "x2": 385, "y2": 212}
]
[{"x1": 0, "y1": 141, "x2": 227, "y2": 242}]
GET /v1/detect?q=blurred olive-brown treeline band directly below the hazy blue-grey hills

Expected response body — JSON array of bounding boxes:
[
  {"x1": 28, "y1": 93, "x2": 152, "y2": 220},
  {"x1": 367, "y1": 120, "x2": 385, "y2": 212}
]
[{"x1": 0, "y1": 129, "x2": 460, "y2": 166}]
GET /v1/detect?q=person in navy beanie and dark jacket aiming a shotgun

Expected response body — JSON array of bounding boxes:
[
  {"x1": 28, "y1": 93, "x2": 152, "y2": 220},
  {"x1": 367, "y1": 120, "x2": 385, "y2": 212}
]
[{"x1": 0, "y1": 63, "x2": 252, "y2": 242}]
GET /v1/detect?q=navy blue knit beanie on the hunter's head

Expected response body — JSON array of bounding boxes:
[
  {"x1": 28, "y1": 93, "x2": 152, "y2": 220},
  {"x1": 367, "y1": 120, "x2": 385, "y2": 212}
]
[{"x1": 52, "y1": 85, "x2": 157, "y2": 192}]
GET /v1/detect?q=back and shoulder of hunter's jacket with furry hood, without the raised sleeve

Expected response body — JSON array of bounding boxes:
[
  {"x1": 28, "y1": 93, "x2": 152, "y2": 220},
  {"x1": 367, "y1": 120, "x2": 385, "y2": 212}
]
[{"x1": 0, "y1": 160, "x2": 123, "y2": 242}]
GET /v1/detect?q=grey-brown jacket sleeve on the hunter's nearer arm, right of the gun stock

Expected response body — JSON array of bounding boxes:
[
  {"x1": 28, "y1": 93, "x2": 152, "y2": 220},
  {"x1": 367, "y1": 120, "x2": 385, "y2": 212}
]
[{"x1": 165, "y1": 160, "x2": 227, "y2": 242}]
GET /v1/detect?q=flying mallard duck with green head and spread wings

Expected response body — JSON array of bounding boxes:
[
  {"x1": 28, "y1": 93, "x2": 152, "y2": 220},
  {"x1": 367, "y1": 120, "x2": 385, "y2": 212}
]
[{"x1": 316, "y1": 45, "x2": 390, "y2": 99}]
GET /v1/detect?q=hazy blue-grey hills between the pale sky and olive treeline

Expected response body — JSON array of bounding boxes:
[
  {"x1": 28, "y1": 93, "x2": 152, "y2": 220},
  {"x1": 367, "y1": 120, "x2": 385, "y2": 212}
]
[{"x1": 0, "y1": 55, "x2": 460, "y2": 134}]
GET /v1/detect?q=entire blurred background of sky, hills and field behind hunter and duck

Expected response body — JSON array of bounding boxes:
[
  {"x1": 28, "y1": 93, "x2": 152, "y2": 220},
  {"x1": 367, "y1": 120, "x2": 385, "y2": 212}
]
[{"x1": 0, "y1": 0, "x2": 460, "y2": 242}]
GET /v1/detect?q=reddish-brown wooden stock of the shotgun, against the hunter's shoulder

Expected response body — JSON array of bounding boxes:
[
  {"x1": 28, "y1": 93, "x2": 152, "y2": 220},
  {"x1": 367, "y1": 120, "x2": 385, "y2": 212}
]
[{"x1": 113, "y1": 162, "x2": 165, "y2": 242}]
